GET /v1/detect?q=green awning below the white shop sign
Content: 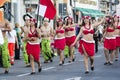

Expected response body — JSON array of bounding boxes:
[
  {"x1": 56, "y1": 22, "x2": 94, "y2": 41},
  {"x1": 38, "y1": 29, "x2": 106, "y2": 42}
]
[{"x1": 75, "y1": 7, "x2": 105, "y2": 17}]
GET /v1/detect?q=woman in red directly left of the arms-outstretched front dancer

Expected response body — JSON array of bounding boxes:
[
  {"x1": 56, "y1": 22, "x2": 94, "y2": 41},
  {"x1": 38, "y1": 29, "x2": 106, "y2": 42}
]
[{"x1": 65, "y1": 17, "x2": 76, "y2": 62}]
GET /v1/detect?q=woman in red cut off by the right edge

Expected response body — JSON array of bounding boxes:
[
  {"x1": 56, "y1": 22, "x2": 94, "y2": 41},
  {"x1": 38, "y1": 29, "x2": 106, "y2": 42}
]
[{"x1": 114, "y1": 15, "x2": 120, "y2": 61}]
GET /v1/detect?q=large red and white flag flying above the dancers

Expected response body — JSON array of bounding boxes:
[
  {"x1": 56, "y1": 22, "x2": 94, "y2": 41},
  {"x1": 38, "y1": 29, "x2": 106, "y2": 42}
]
[{"x1": 36, "y1": 0, "x2": 56, "y2": 19}]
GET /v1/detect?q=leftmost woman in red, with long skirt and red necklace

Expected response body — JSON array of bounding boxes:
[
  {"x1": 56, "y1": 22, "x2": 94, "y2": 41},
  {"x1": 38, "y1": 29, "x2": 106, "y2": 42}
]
[{"x1": 26, "y1": 18, "x2": 41, "y2": 74}]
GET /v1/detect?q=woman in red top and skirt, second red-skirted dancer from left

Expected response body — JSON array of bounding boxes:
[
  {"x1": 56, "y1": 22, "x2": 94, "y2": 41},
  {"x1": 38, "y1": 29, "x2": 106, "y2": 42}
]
[{"x1": 54, "y1": 19, "x2": 66, "y2": 65}]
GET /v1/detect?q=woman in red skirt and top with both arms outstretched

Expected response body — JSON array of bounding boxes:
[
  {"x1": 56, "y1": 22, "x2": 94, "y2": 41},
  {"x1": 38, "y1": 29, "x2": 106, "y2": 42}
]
[{"x1": 71, "y1": 16, "x2": 104, "y2": 74}]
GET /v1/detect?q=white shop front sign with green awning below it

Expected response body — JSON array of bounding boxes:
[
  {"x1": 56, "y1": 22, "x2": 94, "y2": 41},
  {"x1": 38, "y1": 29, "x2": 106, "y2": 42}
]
[{"x1": 74, "y1": 0, "x2": 104, "y2": 17}]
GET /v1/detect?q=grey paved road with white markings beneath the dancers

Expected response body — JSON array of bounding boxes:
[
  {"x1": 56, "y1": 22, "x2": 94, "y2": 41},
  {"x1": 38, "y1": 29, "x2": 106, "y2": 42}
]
[{"x1": 0, "y1": 47, "x2": 120, "y2": 80}]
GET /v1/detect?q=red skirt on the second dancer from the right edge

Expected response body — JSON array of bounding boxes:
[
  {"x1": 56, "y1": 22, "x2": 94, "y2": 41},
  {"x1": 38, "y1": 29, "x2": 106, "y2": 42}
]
[{"x1": 104, "y1": 39, "x2": 116, "y2": 50}]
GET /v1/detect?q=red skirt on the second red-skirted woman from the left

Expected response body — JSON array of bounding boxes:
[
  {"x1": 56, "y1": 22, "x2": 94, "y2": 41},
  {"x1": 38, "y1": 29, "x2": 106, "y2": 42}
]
[{"x1": 54, "y1": 38, "x2": 66, "y2": 50}]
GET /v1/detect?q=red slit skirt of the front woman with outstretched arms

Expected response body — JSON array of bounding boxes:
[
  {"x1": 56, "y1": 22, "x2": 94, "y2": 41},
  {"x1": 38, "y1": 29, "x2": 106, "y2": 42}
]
[{"x1": 78, "y1": 40, "x2": 95, "y2": 56}]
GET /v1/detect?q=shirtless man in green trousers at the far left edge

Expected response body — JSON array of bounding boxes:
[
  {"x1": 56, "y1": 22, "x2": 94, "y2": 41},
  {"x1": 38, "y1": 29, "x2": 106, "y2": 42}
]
[{"x1": 0, "y1": 20, "x2": 11, "y2": 74}]
